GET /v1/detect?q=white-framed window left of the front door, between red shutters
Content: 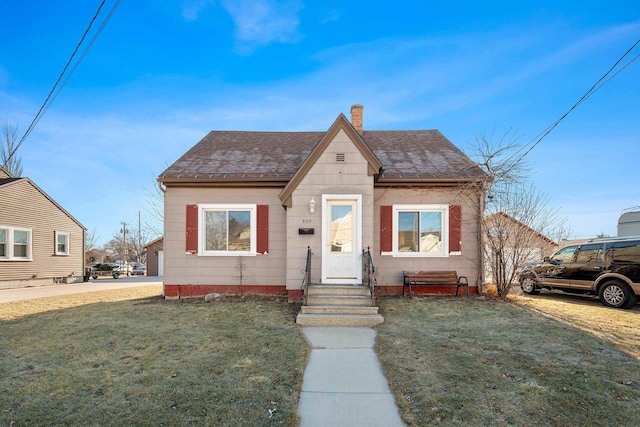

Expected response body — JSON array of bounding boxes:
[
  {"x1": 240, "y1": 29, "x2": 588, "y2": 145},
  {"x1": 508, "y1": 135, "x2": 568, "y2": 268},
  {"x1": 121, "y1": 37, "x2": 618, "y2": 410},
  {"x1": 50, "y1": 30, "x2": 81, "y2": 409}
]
[{"x1": 198, "y1": 204, "x2": 256, "y2": 256}]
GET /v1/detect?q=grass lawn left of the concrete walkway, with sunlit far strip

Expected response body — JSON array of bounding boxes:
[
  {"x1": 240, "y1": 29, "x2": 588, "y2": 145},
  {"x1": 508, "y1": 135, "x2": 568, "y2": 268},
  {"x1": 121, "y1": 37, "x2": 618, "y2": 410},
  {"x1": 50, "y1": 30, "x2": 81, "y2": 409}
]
[{"x1": 0, "y1": 287, "x2": 309, "y2": 426}]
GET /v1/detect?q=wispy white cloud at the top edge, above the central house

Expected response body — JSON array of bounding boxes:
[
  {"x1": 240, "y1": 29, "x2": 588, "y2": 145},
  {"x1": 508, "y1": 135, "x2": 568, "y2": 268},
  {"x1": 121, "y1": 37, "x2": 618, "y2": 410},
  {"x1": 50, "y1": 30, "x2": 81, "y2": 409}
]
[{"x1": 222, "y1": 0, "x2": 303, "y2": 54}]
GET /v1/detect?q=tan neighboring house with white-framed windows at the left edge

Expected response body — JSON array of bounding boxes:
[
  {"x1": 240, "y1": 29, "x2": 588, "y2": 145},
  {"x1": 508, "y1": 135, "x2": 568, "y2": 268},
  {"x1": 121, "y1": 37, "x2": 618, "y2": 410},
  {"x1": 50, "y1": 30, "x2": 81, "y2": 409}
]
[{"x1": 0, "y1": 167, "x2": 86, "y2": 289}]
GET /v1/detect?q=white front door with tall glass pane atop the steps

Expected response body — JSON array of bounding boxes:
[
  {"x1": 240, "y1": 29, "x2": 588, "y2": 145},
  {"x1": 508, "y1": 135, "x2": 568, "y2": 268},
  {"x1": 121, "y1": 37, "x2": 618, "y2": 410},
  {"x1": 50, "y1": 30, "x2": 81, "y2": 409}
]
[{"x1": 322, "y1": 194, "x2": 362, "y2": 284}]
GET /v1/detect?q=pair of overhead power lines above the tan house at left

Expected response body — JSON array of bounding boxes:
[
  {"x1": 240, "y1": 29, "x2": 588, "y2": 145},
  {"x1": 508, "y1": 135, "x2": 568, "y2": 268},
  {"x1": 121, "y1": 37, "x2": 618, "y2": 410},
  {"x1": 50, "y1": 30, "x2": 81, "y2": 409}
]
[{"x1": 9, "y1": 0, "x2": 121, "y2": 158}]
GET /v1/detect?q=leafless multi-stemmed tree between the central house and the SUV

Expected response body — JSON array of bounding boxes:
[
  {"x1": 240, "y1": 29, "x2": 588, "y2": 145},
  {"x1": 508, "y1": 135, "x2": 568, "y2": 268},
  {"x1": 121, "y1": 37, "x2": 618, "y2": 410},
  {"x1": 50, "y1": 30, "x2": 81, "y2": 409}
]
[{"x1": 464, "y1": 131, "x2": 566, "y2": 299}]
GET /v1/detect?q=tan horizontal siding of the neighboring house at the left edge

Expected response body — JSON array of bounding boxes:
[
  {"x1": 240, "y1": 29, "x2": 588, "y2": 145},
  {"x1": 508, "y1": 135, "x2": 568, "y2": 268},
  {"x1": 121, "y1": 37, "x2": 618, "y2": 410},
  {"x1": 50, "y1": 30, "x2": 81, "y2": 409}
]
[{"x1": 0, "y1": 179, "x2": 84, "y2": 287}]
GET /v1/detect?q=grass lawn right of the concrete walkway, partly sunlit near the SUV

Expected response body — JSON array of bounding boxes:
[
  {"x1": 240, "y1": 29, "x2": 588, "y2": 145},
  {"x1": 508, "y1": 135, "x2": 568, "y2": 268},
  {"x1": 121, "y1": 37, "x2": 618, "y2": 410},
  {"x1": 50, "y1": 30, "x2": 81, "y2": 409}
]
[{"x1": 376, "y1": 295, "x2": 640, "y2": 426}]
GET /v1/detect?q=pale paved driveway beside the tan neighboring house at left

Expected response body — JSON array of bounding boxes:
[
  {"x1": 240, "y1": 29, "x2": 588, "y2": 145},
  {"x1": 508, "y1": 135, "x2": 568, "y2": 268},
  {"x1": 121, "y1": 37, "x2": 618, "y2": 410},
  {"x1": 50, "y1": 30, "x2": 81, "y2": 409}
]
[{"x1": 0, "y1": 276, "x2": 162, "y2": 304}]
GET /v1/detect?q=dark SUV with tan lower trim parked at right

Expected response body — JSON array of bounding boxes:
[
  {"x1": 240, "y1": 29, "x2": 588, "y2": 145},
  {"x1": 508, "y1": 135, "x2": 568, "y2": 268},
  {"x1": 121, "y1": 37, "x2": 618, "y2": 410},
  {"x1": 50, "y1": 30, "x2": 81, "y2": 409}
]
[{"x1": 519, "y1": 236, "x2": 640, "y2": 308}]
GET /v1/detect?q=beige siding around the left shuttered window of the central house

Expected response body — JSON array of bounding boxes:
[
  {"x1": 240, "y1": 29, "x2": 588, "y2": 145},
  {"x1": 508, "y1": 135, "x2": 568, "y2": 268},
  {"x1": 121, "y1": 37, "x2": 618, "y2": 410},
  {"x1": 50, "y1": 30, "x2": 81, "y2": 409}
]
[{"x1": 164, "y1": 187, "x2": 286, "y2": 286}]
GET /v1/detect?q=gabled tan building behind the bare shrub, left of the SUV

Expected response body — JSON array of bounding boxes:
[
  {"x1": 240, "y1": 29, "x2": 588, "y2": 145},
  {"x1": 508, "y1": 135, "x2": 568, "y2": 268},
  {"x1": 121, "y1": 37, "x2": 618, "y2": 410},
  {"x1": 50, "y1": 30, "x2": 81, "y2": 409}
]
[{"x1": 485, "y1": 212, "x2": 559, "y2": 283}]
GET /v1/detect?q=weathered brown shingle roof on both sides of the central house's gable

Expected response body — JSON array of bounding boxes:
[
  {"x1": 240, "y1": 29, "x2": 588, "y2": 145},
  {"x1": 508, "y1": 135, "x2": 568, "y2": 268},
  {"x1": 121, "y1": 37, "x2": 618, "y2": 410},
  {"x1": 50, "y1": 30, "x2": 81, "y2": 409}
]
[{"x1": 160, "y1": 130, "x2": 484, "y2": 182}]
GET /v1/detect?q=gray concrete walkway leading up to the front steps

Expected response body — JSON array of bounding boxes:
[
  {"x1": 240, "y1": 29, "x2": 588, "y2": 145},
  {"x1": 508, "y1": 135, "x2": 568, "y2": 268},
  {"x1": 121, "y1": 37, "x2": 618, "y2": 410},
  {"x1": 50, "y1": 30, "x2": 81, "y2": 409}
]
[{"x1": 298, "y1": 327, "x2": 404, "y2": 427}]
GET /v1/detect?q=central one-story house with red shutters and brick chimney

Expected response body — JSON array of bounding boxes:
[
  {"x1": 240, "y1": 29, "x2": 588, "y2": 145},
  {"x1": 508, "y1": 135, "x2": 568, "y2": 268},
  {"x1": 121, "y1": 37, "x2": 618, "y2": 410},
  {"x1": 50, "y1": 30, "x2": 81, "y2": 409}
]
[{"x1": 158, "y1": 105, "x2": 487, "y2": 301}]
